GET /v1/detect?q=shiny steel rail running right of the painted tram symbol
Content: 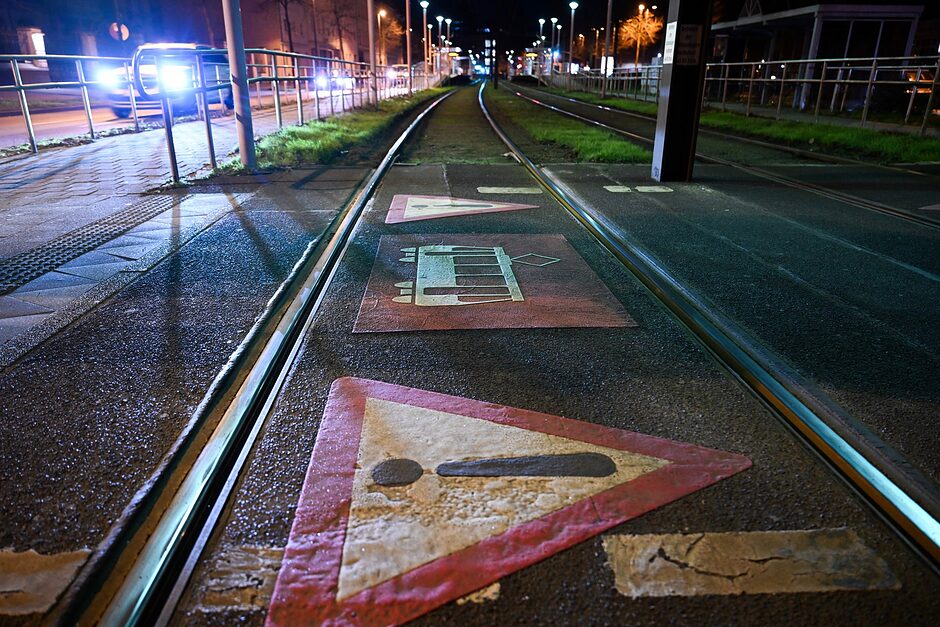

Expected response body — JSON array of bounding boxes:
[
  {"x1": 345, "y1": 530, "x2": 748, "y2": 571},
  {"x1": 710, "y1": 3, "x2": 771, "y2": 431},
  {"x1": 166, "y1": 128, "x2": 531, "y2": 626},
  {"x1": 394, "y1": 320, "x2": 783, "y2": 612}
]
[{"x1": 478, "y1": 78, "x2": 940, "y2": 572}]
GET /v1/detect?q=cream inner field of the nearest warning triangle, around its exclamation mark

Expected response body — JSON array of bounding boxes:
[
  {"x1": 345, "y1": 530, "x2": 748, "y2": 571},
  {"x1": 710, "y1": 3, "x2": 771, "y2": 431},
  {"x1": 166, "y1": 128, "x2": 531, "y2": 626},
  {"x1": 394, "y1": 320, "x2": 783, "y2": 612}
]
[{"x1": 337, "y1": 398, "x2": 668, "y2": 600}]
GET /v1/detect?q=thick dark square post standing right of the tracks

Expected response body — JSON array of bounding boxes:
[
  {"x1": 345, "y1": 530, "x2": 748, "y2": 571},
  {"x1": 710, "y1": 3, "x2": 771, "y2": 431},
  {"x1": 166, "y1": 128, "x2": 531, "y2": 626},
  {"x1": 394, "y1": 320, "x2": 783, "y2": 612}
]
[{"x1": 652, "y1": 0, "x2": 711, "y2": 181}]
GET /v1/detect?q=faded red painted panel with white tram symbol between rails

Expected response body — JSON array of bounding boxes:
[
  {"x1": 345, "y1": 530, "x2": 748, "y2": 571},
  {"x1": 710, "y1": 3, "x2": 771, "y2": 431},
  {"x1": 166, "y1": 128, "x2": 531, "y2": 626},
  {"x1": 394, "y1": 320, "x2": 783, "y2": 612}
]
[{"x1": 353, "y1": 234, "x2": 636, "y2": 333}]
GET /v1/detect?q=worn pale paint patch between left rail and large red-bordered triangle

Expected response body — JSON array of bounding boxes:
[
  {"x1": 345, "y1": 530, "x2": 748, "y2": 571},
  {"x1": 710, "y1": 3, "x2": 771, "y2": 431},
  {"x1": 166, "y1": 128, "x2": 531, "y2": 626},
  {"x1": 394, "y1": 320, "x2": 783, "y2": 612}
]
[{"x1": 189, "y1": 546, "x2": 284, "y2": 612}]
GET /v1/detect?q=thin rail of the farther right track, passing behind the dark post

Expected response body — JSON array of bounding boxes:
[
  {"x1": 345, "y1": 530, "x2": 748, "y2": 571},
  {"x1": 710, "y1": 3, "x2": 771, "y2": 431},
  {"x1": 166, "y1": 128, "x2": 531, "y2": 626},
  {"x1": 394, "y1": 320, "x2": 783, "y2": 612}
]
[{"x1": 513, "y1": 83, "x2": 940, "y2": 229}]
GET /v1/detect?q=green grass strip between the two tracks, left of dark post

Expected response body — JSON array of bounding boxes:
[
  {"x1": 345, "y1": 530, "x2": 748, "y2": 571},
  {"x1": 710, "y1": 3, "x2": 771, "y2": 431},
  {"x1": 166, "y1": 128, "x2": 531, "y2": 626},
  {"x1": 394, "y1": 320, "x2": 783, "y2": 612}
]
[{"x1": 487, "y1": 89, "x2": 653, "y2": 163}]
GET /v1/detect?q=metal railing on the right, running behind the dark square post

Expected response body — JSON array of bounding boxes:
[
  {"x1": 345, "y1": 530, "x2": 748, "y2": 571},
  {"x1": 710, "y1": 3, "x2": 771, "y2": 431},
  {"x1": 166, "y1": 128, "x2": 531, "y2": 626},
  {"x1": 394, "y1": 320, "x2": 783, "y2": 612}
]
[{"x1": 550, "y1": 56, "x2": 940, "y2": 134}]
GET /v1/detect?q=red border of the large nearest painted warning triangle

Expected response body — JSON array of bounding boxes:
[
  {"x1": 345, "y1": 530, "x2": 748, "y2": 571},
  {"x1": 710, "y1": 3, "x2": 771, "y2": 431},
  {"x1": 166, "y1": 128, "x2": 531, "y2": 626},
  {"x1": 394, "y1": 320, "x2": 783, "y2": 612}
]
[{"x1": 267, "y1": 378, "x2": 751, "y2": 625}]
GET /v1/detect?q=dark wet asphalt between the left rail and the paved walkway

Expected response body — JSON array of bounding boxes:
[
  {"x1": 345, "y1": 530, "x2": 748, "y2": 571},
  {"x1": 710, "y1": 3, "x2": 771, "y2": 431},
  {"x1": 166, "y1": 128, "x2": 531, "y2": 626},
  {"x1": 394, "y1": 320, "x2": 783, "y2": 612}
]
[{"x1": 0, "y1": 168, "x2": 367, "y2": 553}]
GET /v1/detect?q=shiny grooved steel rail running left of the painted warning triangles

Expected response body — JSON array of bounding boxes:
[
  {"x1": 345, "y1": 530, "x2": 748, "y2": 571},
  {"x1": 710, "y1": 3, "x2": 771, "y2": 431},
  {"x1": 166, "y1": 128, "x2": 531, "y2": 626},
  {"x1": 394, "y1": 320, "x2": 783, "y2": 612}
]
[{"x1": 62, "y1": 91, "x2": 453, "y2": 626}]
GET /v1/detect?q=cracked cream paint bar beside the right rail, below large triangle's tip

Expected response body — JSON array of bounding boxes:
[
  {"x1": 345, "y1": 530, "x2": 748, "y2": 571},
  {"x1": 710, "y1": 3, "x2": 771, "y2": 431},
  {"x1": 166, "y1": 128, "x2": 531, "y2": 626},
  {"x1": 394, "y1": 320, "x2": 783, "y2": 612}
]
[{"x1": 604, "y1": 529, "x2": 901, "y2": 598}]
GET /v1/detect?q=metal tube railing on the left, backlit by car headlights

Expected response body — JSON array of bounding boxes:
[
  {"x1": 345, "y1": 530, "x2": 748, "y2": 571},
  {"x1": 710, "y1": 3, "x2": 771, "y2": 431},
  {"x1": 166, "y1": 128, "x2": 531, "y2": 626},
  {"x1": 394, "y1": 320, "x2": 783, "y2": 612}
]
[{"x1": 0, "y1": 45, "x2": 444, "y2": 181}]
